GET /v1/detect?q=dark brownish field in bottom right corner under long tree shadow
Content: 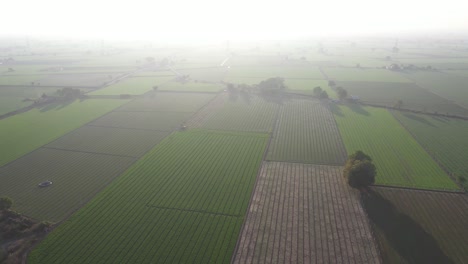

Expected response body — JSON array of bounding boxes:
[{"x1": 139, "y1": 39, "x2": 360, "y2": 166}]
[{"x1": 363, "y1": 187, "x2": 468, "y2": 263}]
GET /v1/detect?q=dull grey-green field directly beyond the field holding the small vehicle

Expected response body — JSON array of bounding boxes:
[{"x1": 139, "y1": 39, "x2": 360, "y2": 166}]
[{"x1": 45, "y1": 126, "x2": 169, "y2": 157}]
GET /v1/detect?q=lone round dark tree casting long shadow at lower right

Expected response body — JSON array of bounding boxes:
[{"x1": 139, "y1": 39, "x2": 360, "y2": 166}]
[{"x1": 343, "y1": 151, "x2": 377, "y2": 188}]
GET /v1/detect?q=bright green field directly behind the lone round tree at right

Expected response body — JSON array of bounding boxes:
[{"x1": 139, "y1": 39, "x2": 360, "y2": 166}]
[{"x1": 332, "y1": 105, "x2": 459, "y2": 190}]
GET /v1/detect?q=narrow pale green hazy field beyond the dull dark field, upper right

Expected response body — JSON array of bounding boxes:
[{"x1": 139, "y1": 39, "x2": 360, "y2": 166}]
[{"x1": 324, "y1": 68, "x2": 411, "y2": 83}]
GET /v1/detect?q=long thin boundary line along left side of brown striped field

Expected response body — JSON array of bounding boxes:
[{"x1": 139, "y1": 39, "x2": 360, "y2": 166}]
[{"x1": 231, "y1": 98, "x2": 282, "y2": 263}]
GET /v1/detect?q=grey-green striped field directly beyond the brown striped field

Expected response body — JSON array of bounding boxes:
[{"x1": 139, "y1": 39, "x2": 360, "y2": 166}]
[{"x1": 267, "y1": 99, "x2": 347, "y2": 165}]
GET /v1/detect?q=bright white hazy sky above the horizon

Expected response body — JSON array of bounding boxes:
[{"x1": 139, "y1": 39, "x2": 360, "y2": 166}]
[{"x1": 0, "y1": 0, "x2": 468, "y2": 39}]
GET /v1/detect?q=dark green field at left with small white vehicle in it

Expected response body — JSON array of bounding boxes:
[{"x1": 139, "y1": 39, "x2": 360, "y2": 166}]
[{"x1": 0, "y1": 148, "x2": 135, "y2": 222}]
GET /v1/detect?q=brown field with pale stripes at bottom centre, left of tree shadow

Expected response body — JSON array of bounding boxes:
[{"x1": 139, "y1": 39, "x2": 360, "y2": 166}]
[{"x1": 233, "y1": 162, "x2": 381, "y2": 264}]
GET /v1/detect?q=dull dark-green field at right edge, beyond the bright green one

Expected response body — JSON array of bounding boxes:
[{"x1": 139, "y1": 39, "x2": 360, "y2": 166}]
[{"x1": 337, "y1": 82, "x2": 468, "y2": 116}]
